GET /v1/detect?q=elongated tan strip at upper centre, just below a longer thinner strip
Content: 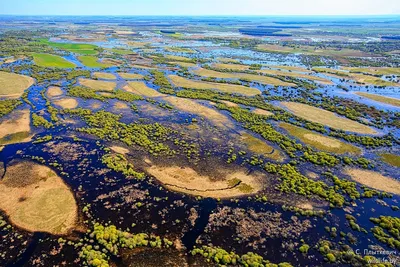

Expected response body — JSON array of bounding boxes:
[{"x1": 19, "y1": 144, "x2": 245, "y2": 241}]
[{"x1": 168, "y1": 75, "x2": 261, "y2": 96}]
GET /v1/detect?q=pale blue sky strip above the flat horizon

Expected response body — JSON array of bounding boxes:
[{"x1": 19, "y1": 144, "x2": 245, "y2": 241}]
[{"x1": 0, "y1": 0, "x2": 400, "y2": 16}]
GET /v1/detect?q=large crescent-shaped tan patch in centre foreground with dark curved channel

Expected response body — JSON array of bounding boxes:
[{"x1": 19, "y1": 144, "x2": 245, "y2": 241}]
[{"x1": 146, "y1": 166, "x2": 262, "y2": 198}]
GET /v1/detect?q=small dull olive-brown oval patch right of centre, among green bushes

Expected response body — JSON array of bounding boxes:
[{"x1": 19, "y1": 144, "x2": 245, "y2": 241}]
[{"x1": 240, "y1": 132, "x2": 285, "y2": 161}]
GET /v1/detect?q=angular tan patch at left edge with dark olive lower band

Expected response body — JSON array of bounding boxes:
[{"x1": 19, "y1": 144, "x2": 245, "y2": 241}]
[{"x1": 0, "y1": 110, "x2": 32, "y2": 145}]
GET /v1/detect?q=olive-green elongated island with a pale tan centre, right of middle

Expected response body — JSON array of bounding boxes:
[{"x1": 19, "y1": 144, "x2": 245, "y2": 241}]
[{"x1": 279, "y1": 122, "x2": 361, "y2": 155}]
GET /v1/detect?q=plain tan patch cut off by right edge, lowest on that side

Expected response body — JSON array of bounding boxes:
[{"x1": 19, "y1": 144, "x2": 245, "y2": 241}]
[{"x1": 345, "y1": 168, "x2": 400, "y2": 195}]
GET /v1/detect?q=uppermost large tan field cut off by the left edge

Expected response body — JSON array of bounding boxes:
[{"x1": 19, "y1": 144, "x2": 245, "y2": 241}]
[{"x1": 0, "y1": 71, "x2": 35, "y2": 97}]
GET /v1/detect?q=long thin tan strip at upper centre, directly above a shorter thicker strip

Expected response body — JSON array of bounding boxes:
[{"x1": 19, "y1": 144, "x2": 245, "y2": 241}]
[{"x1": 193, "y1": 68, "x2": 295, "y2": 86}]
